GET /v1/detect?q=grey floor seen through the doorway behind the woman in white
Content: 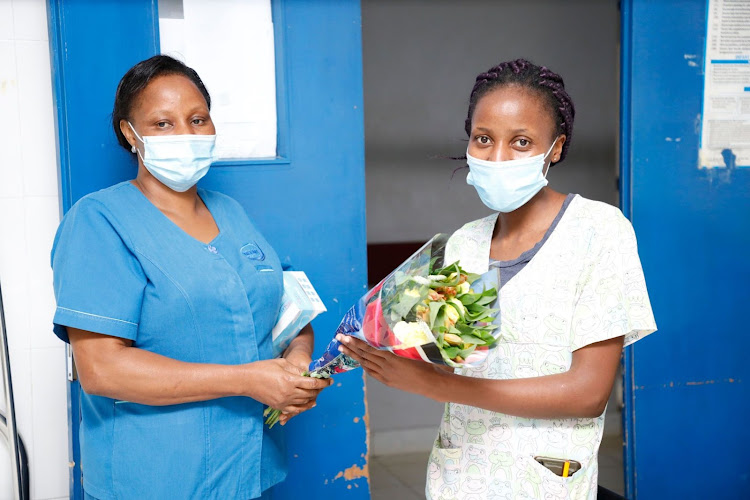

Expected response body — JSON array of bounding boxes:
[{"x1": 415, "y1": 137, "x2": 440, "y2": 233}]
[{"x1": 370, "y1": 434, "x2": 625, "y2": 500}]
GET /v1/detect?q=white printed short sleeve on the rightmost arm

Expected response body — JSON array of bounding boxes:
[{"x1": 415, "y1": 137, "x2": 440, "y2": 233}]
[{"x1": 571, "y1": 213, "x2": 656, "y2": 350}]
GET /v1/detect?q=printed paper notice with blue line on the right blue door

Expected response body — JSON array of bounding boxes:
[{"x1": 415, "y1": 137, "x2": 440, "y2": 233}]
[{"x1": 700, "y1": 0, "x2": 750, "y2": 168}]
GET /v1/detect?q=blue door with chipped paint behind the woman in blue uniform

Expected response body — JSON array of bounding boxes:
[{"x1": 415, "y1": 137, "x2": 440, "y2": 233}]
[{"x1": 48, "y1": 0, "x2": 369, "y2": 499}]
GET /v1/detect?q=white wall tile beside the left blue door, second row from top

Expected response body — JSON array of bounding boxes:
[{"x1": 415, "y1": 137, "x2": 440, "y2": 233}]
[{"x1": 16, "y1": 41, "x2": 58, "y2": 196}]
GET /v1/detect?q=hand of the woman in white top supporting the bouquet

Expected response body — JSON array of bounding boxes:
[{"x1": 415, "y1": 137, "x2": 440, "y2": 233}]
[{"x1": 336, "y1": 335, "x2": 445, "y2": 398}]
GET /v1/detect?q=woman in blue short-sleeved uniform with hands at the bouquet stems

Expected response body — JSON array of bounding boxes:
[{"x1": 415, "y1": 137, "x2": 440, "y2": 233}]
[{"x1": 52, "y1": 56, "x2": 330, "y2": 500}]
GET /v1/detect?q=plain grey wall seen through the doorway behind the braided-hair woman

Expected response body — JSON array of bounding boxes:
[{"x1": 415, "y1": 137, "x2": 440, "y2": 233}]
[{"x1": 362, "y1": 0, "x2": 619, "y2": 454}]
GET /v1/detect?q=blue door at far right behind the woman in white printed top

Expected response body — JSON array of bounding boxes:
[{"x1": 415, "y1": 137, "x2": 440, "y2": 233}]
[{"x1": 621, "y1": 0, "x2": 750, "y2": 499}]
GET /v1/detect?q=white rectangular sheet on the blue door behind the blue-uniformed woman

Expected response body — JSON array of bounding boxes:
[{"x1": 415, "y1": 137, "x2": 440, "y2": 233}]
[{"x1": 159, "y1": 0, "x2": 277, "y2": 160}]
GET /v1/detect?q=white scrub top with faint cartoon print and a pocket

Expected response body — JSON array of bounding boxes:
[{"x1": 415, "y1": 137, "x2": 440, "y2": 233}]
[{"x1": 426, "y1": 196, "x2": 656, "y2": 500}]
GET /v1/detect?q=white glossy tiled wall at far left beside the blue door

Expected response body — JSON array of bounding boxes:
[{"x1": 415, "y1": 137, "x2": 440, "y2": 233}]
[{"x1": 0, "y1": 0, "x2": 68, "y2": 499}]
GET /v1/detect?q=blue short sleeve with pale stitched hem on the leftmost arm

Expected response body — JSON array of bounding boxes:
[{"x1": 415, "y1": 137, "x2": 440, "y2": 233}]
[{"x1": 52, "y1": 198, "x2": 146, "y2": 342}]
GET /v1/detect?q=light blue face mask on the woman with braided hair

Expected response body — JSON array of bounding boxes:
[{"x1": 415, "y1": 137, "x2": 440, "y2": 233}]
[{"x1": 466, "y1": 137, "x2": 557, "y2": 213}]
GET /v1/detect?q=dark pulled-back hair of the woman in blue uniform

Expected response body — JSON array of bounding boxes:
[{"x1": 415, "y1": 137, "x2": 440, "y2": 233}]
[{"x1": 112, "y1": 55, "x2": 211, "y2": 151}]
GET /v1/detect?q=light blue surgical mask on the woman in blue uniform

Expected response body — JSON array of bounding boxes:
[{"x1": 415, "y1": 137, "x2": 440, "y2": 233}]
[{"x1": 128, "y1": 122, "x2": 216, "y2": 193}]
